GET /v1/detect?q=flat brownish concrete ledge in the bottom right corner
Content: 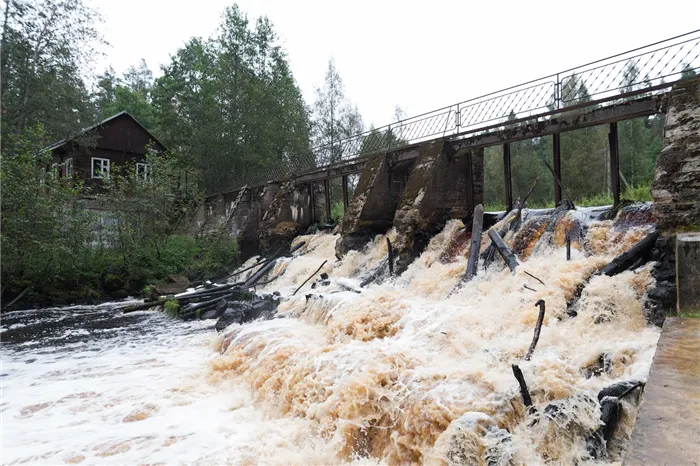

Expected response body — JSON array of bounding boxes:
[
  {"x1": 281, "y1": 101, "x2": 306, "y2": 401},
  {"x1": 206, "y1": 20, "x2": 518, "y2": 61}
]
[{"x1": 624, "y1": 317, "x2": 700, "y2": 466}]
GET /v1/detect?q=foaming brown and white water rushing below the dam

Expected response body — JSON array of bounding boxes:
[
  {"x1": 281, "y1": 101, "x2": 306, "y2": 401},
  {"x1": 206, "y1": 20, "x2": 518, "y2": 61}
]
[{"x1": 0, "y1": 209, "x2": 659, "y2": 465}]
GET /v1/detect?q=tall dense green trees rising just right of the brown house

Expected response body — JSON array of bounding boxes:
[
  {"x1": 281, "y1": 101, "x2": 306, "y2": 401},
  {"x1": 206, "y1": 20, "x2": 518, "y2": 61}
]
[{"x1": 152, "y1": 6, "x2": 309, "y2": 192}]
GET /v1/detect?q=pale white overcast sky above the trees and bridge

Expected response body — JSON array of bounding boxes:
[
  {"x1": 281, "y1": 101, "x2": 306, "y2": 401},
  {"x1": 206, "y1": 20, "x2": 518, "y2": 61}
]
[{"x1": 91, "y1": 0, "x2": 700, "y2": 126}]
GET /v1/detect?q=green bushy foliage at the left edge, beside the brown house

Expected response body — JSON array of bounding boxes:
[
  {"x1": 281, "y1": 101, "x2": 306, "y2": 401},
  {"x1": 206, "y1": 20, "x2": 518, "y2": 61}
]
[{"x1": 0, "y1": 128, "x2": 93, "y2": 286}]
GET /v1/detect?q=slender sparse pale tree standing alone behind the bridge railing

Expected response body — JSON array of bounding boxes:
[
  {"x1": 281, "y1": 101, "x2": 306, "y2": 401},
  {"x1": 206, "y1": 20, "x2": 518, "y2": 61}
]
[{"x1": 312, "y1": 58, "x2": 364, "y2": 165}]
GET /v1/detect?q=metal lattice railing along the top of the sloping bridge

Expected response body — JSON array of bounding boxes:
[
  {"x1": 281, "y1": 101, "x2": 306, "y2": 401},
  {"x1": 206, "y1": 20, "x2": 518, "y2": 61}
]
[{"x1": 219, "y1": 29, "x2": 700, "y2": 191}]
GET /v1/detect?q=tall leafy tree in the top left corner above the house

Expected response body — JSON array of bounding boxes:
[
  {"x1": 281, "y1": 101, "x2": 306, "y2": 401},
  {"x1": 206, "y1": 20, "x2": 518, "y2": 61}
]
[{"x1": 0, "y1": 0, "x2": 101, "y2": 146}]
